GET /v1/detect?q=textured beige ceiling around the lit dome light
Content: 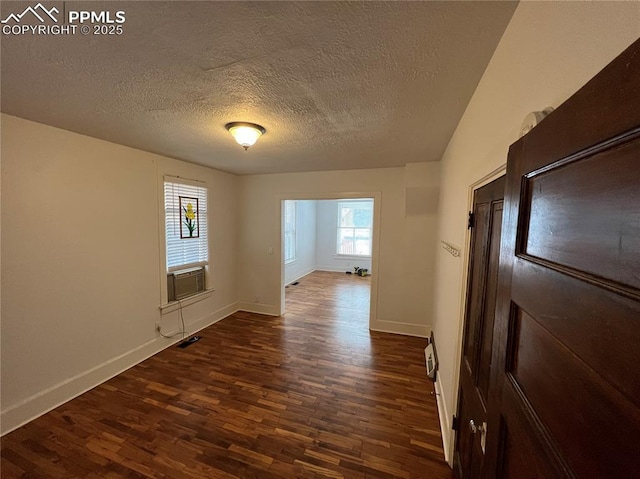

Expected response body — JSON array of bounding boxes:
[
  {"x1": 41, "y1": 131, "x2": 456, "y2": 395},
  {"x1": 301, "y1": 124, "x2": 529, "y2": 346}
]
[{"x1": 1, "y1": 1, "x2": 516, "y2": 174}]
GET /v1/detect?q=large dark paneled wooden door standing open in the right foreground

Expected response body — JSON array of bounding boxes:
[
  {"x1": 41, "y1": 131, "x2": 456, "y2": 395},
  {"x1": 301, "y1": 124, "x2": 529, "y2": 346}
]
[{"x1": 484, "y1": 40, "x2": 640, "y2": 479}]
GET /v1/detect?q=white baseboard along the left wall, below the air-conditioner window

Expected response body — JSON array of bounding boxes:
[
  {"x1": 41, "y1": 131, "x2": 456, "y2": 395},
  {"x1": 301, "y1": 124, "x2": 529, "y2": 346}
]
[{"x1": 0, "y1": 303, "x2": 238, "y2": 435}]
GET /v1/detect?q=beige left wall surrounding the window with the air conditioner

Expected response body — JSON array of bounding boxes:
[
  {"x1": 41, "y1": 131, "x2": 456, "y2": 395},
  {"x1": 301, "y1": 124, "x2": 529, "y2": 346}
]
[{"x1": 1, "y1": 115, "x2": 237, "y2": 431}]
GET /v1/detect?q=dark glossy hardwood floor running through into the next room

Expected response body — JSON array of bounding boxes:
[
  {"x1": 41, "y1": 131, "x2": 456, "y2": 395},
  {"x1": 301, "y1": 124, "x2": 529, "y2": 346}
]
[{"x1": 1, "y1": 272, "x2": 451, "y2": 479}]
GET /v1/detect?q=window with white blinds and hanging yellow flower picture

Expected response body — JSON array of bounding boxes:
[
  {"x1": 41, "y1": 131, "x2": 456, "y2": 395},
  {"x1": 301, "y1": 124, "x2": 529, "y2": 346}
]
[{"x1": 164, "y1": 179, "x2": 209, "y2": 273}]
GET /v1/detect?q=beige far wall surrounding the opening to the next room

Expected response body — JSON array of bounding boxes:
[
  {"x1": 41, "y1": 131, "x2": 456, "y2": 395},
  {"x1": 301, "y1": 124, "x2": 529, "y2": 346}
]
[{"x1": 238, "y1": 163, "x2": 439, "y2": 335}]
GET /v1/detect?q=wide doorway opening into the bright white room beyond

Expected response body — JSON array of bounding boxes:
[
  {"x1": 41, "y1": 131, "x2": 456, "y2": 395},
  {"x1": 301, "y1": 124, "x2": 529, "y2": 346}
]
[{"x1": 279, "y1": 193, "x2": 379, "y2": 329}]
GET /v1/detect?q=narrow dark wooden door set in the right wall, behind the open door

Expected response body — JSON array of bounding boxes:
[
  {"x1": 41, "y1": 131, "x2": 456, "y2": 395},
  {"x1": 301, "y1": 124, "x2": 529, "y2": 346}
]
[{"x1": 454, "y1": 176, "x2": 505, "y2": 478}]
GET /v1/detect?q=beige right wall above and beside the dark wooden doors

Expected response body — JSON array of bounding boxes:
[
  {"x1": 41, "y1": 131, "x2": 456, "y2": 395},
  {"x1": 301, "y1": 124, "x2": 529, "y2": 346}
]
[{"x1": 434, "y1": 2, "x2": 640, "y2": 464}]
